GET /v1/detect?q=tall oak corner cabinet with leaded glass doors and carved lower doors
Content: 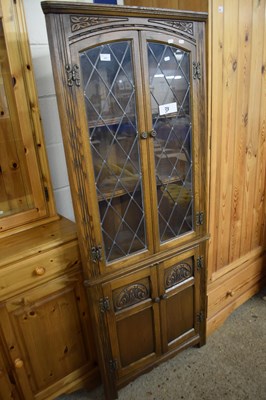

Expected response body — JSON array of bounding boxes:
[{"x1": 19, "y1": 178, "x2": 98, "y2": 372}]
[{"x1": 42, "y1": 2, "x2": 208, "y2": 399}]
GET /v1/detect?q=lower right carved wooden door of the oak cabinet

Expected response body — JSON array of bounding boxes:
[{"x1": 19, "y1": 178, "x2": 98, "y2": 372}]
[{"x1": 159, "y1": 248, "x2": 201, "y2": 352}]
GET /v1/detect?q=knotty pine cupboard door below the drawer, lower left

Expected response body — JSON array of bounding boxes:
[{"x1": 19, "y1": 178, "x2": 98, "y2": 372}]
[{"x1": 1, "y1": 274, "x2": 96, "y2": 400}]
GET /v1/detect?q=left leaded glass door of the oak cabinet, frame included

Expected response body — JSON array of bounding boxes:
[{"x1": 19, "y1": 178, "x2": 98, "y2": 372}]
[{"x1": 72, "y1": 29, "x2": 153, "y2": 269}]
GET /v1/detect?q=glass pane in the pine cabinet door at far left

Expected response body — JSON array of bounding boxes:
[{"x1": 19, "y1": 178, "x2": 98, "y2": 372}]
[{"x1": 0, "y1": 22, "x2": 34, "y2": 218}]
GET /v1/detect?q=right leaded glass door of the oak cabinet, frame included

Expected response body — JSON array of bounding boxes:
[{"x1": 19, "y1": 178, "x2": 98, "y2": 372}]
[{"x1": 142, "y1": 33, "x2": 199, "y2": 251}]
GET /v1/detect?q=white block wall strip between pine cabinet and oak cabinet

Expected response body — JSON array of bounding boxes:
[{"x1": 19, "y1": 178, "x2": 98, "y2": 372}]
[{"x1": 23, "y1": 0, "x2": 123, "y2": 221}]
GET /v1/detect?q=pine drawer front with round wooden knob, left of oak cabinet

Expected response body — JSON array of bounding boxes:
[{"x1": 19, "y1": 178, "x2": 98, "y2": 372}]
[{"x1": 0, "y1": 241, "x2": 80, "y2": 301}]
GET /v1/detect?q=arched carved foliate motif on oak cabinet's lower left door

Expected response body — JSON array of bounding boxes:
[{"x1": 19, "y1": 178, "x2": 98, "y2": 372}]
[{"x1": 114, "y1": 283, "x2": 150, "y2": 311}]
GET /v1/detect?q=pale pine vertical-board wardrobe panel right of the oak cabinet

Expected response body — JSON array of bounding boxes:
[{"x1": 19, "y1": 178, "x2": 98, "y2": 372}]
[{"x1": 209, "y1": 0, "x2": 266, "y2": 280}]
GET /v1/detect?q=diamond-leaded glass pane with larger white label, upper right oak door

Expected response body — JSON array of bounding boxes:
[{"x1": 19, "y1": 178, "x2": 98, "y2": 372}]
[{"x1": 148, "y1": 42, "x2": 193, "y2": 242}]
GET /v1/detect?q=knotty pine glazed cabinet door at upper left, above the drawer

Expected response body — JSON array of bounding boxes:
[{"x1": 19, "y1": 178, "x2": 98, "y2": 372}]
[{"x1": 0, "y1": 0, "x2": 57, "y2": 236}]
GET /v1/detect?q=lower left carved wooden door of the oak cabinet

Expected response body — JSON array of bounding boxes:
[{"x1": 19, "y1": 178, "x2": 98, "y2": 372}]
[{"x1": 103, "y1": 266, "x2": 161, "y2": 380}]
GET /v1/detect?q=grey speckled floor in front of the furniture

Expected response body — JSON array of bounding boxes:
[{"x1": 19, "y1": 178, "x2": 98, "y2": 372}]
[{"x1": 57, "y1": 288, "x2": 266, "y2": 400}]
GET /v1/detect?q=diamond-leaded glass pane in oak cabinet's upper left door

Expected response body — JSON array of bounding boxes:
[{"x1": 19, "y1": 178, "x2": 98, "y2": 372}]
[{"x1": 80, "y1": 41, "x2": 146, "y2": 262}]
